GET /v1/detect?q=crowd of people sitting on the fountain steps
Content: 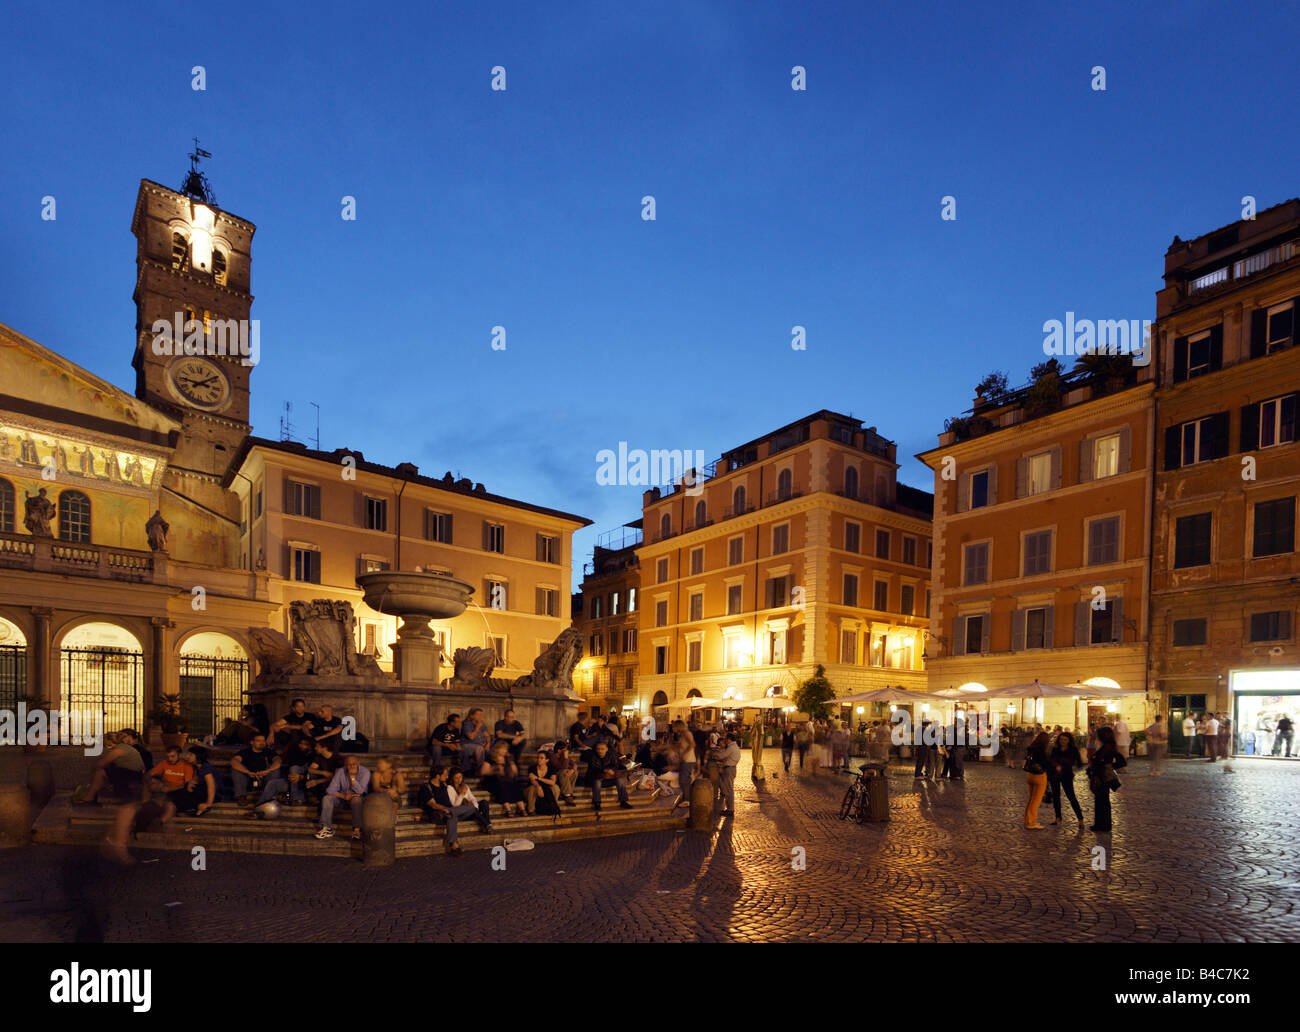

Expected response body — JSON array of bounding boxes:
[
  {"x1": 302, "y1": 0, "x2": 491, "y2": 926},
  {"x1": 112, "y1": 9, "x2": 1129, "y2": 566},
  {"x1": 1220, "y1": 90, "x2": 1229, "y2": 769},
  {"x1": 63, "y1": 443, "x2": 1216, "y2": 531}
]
[{"x1": 75, "y1": 699, "x2": 740, "y2": 855}]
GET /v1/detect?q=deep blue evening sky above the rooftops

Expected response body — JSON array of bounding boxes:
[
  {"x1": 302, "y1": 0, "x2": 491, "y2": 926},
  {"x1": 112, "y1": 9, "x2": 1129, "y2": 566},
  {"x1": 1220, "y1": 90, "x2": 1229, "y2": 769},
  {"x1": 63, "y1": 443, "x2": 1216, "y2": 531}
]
[{"x1": 0, "y1": 0, "x2": 1300, "y2": 582}]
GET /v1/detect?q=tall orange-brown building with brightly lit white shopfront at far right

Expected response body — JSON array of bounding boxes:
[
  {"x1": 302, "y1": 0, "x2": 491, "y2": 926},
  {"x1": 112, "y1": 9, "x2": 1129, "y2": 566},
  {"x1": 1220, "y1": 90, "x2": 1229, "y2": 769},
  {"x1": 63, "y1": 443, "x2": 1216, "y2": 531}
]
[{"x1": 1151, "y1": 200, "x2": 1300, "y2": 755}]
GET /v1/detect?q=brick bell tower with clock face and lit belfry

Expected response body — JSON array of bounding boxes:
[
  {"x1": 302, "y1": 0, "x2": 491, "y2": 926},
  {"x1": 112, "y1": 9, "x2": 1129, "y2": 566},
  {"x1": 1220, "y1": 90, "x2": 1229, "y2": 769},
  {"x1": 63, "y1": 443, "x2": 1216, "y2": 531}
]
[{"x1": 131, "y1": 140, "x2": 260, "y2": 480}]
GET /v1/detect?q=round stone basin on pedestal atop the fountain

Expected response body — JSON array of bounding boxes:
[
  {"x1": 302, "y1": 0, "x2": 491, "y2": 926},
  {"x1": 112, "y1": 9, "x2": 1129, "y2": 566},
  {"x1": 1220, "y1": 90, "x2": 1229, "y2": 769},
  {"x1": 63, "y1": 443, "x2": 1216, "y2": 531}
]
[{"x1": 356, "y1": 569, "x2": 475, "y2": 684}]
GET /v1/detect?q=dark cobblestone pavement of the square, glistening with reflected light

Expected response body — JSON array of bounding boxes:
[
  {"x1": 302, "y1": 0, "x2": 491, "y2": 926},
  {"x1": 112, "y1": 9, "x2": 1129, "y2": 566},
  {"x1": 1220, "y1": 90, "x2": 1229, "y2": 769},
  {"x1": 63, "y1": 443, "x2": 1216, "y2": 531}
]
[{"x1": 0, "y1": 753, "x2": 1300, "y2": 942}]
